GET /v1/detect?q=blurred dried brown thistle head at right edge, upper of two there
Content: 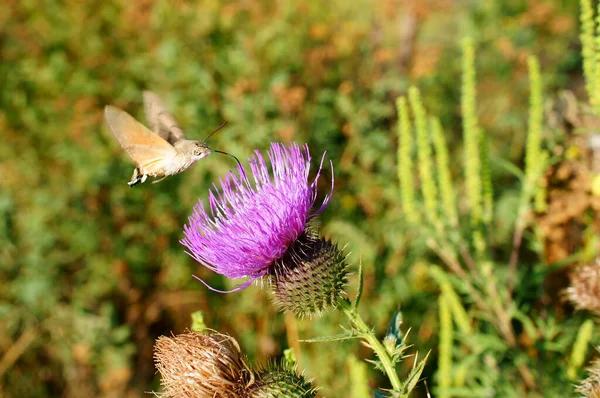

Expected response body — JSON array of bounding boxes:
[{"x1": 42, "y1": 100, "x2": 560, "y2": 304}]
[{"x1": 565, "y1": 262, "x2": 600, "y2": 315}]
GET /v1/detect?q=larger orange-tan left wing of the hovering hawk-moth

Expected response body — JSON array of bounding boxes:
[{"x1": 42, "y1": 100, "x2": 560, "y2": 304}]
[{"x1": 104, "y1": 105, "x2": 177, "y2": 172}]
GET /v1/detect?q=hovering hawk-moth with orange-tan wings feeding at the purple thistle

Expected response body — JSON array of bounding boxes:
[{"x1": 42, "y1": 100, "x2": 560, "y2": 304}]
[{"x1": 104, "y1": 91, "x2": 239, "y2": 187}]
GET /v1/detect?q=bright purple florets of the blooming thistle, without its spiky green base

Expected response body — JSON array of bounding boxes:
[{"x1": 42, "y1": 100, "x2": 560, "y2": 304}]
[{"x1": 181, "y1": 143, "x2": 333, "y2": 293}]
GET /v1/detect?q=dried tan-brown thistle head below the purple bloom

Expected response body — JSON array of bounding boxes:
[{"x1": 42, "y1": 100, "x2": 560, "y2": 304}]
[{"x1": 154, "y1": 332, "x2": 254, "y2": 398}]
